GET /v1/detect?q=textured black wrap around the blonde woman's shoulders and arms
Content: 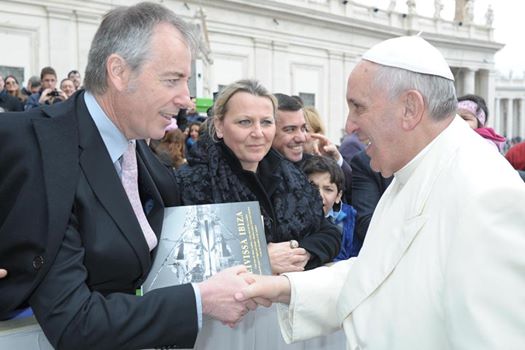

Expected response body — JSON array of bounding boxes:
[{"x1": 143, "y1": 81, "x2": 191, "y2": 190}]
[{"x1": 177, "y1": 137, "x2": 323, "y2": 242}]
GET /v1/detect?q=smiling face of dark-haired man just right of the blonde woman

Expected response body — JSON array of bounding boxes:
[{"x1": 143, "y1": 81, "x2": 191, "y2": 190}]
[{"x1": 272, "y1": 109, "x2": 307, "y2": 162}]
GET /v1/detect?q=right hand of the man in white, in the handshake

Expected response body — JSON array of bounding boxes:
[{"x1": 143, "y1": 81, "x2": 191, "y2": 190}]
[{"x1": 235, "y1": 275, "x2": 292, "y2": 307}]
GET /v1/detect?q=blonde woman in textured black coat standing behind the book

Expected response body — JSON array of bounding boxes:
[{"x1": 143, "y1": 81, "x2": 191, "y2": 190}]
[{"x1": 177, "y1": 80, "x2": 341, "y2": 274}]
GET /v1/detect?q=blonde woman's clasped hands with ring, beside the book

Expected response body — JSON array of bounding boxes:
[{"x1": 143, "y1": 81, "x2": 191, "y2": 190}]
[{"x1": 268, "y1": 241, "x2": 310, "y2": 275}]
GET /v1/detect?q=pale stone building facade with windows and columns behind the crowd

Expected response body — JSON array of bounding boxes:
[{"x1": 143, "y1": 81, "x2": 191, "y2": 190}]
[{"x1": 0, "y1": 0, "x2": 525, "y2": 141}]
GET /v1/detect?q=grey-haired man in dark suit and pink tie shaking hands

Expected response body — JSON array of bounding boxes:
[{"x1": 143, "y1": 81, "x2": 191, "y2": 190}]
[{"x1": 0, "y1": 3, "x2": 255, "y2": 349}]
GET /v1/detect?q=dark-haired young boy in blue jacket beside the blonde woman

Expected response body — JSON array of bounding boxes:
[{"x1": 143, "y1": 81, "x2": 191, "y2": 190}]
[{"x1": 302, "y1": 156, "x2": 362, "y2": 261}]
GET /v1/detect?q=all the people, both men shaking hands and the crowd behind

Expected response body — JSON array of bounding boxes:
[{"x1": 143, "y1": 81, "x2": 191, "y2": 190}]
[{"x1": 0, "y1": 2, "x2": 525, "y2": 349}]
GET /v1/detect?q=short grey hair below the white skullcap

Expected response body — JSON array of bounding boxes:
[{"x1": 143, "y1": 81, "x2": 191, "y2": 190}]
[{"x1": 374, "y1": 65, "x2": 458, "y2": 121}]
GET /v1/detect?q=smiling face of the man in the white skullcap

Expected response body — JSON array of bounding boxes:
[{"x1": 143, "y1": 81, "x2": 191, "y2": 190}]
[{"x1": 346, "y1": 61, "x2": 406, "y2": 177}]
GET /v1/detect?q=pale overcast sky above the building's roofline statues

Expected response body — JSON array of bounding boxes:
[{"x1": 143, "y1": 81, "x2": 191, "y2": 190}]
[{"x1": 355, "y1": 0, "x2": 525, "y2": 77}]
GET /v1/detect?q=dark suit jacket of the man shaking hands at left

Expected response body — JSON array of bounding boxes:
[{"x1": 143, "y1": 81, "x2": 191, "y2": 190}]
[{"x1": 0, "y1": 93, "x2": 198, "y2": 349}]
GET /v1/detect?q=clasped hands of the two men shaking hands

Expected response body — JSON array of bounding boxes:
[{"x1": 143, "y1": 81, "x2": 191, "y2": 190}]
[{"x1": 197, "y1": 265, "x2": 290, "y2": 327}]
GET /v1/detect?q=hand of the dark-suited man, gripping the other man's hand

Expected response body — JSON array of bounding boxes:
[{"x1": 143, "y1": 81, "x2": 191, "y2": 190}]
[{"x1": 197, "y1": 265, "x2": 257, "y2": 327}]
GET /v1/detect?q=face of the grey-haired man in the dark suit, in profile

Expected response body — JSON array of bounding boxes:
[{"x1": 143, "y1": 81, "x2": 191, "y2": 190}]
[{"x1": 114, "y1": 23, "x2": 191, "y2": 139}]
